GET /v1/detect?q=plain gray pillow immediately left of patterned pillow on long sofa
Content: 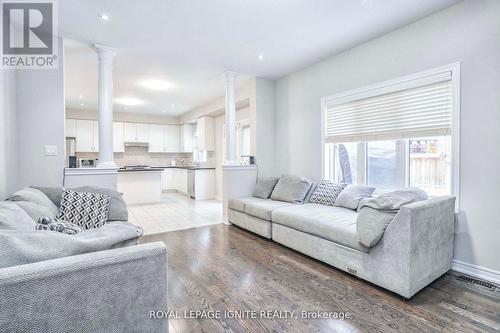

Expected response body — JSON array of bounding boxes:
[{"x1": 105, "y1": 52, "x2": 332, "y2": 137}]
[{"x1": 271, "y1": 175, "x2": 311, "y2": 204}]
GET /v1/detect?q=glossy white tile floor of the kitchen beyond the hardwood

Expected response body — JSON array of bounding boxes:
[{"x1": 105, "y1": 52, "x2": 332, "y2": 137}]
[{"x1": 128, "y1": 193, "x2": 222, "y2": 235}]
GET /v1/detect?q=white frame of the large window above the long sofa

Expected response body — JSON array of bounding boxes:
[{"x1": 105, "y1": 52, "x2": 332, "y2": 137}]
[{"x1": 320, "y1": 62, "x2": 461, "y2": 212}]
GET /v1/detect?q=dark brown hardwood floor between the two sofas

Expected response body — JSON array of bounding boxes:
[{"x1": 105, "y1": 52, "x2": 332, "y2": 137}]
[{"x1": 141, "y1": 224, "x2": 500, "y2": 333}]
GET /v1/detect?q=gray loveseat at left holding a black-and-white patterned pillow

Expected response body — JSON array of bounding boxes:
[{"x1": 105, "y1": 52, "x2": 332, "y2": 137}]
[{"x1": 0, "y1": 188, "x2": 168, "y2": 332}]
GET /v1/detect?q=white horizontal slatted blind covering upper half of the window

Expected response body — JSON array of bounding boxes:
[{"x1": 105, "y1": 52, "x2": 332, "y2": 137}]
[{"x1": 324, "y1": 72, "x2": 452, "y2": 143}]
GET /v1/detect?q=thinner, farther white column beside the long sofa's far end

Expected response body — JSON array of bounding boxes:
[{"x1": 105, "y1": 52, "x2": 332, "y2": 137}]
[{"x1": 224, "y1": 72, "x2": 237, "y2": 165}]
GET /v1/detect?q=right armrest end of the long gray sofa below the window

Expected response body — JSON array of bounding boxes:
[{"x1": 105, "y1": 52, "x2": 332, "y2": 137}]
[{"x1": 373, "y1": 196, "x2": 455, "y2": 297}]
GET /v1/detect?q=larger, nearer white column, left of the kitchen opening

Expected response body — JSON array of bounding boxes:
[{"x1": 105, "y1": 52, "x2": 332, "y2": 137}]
[{"x1": 94, "y1": 45, "x2": 116, "y2": 168}]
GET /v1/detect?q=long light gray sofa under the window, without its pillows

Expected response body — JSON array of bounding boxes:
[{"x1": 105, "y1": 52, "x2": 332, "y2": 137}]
[{"x1": 228, "y1": 176, "x2": 455, "y2": 298}]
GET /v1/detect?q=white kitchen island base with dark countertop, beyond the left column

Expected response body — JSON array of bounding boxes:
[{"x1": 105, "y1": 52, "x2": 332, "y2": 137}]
[{"x1": 118, "y1": 168, "x2": 163, "y2": 205}]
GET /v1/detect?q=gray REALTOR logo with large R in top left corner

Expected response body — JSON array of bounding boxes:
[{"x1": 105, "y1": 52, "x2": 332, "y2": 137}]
[{"x1": 1, "y1": 0, "x2": 57, "y2": 69}]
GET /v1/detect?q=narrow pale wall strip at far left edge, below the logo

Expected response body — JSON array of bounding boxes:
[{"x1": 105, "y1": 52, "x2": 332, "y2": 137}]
[{"x1": 0, "y1": 69, "x2": 17, "y2": 200}]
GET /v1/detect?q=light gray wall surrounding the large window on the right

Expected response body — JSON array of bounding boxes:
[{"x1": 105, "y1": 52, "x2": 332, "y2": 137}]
[{"x1": 275, "y1": 0, "x2": 500, "y2": 272}]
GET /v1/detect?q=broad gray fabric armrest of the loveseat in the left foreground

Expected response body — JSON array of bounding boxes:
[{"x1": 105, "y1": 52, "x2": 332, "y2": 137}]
[{"x1": 0, "y1": 242, "x2": 168, "y2": 332}]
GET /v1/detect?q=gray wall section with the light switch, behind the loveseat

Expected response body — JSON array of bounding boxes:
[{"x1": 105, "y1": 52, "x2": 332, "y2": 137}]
[{"x1": 16, "y1": 39, "x2": 65, "y2": 188}]
